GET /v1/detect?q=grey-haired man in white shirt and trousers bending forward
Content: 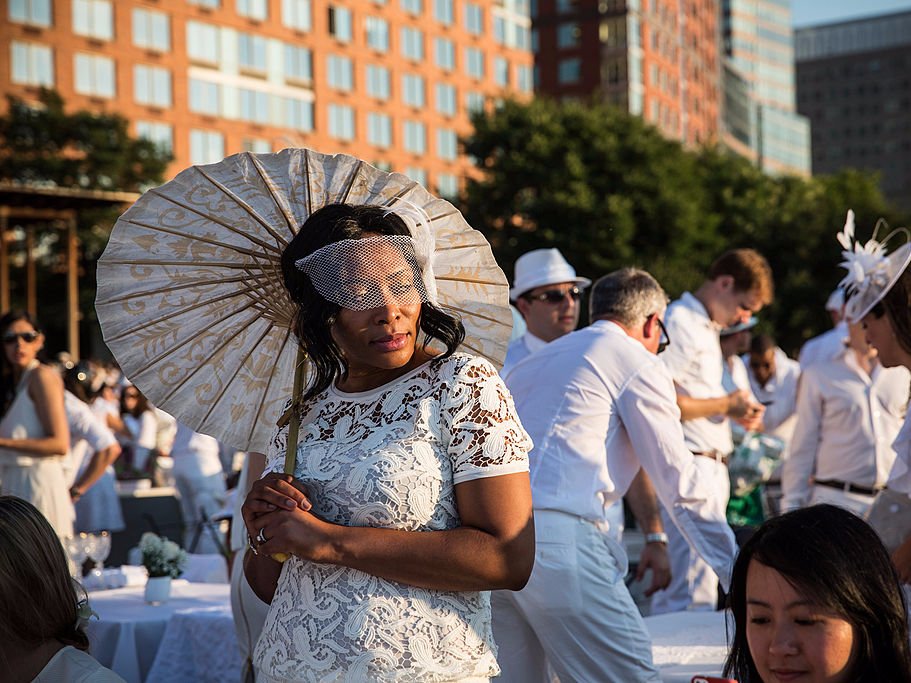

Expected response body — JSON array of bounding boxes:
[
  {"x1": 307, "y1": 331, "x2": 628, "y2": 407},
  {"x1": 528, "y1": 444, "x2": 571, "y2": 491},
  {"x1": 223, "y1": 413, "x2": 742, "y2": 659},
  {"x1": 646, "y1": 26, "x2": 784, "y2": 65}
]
[{"x1": 491, "y1": 268, "x2": 735, "y2": 683}]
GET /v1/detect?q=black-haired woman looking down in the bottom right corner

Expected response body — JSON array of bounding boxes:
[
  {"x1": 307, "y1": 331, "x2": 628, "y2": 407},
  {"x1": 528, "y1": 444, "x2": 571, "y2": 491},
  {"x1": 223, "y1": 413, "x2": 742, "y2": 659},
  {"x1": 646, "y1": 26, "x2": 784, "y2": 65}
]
[{"x1": 724, "y1": 505, "x2": 911, "y2": 683}]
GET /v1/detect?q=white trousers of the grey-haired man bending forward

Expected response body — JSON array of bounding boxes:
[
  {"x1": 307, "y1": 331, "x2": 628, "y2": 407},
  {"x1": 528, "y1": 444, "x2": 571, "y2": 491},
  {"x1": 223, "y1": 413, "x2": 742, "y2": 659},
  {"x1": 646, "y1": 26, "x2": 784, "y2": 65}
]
[{"x1": 490, "y1": 510, "x2": 661, "y2": 683}]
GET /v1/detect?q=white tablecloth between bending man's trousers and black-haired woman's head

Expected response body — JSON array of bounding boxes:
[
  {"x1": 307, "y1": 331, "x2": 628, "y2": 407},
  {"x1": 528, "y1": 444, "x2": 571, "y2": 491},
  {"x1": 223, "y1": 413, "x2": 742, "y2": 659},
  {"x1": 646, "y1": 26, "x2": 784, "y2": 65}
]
[{"x1": 645, "y1": 612, "x2": 734, "y2": 683}]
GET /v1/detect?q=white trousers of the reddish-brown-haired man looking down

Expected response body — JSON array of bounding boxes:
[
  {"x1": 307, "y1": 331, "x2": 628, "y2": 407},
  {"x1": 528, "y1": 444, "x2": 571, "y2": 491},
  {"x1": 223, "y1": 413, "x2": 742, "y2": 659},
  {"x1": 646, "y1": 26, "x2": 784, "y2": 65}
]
[{"x1": 651, "y1": 456, "x2": 731, "y2": 614}]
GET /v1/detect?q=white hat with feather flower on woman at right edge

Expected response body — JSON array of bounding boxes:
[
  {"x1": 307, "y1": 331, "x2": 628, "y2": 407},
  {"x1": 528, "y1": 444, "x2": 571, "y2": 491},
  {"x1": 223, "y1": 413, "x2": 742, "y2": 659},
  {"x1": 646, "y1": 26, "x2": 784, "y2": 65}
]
[{"x1": 838, "y1": 209, "x2": 911, "y2": 323}]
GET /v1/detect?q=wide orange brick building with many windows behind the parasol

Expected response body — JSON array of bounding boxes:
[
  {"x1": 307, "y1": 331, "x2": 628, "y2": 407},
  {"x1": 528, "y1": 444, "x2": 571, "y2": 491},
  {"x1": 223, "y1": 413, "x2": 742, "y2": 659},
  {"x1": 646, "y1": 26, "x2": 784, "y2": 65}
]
[{"x1": 0, "y1": 0, "x2": 533, "y2": 196}]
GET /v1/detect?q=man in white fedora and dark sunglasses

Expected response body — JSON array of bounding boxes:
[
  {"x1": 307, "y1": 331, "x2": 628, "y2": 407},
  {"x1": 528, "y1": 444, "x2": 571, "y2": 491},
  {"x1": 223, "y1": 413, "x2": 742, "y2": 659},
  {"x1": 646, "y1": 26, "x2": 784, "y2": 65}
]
[{"x1": 503, "y1": 249, "x2": 591, "y2": 376}]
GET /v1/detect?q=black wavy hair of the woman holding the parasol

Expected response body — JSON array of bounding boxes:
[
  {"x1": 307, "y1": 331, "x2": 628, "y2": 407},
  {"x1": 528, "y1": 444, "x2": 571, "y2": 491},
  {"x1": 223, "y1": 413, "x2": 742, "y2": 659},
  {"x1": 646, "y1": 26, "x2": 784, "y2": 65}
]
[{"x1": 282, "y1": 204, "x2": 465, "y2": 399}]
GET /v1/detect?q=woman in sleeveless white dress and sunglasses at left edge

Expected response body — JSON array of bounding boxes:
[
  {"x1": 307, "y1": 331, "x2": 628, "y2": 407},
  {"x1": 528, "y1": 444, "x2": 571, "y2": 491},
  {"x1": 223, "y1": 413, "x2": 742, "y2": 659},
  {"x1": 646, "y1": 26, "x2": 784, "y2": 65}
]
[{"x1": 0, "y1": 311, "x2": 74, "y2": 538}]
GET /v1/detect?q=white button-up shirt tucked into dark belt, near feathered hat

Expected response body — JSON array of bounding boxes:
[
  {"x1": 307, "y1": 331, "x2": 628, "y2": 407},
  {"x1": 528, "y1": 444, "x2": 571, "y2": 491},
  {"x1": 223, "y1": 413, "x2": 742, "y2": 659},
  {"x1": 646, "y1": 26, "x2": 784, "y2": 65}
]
[{"x1": 781, "y1": 349, "x2": 911, "y2": 510}]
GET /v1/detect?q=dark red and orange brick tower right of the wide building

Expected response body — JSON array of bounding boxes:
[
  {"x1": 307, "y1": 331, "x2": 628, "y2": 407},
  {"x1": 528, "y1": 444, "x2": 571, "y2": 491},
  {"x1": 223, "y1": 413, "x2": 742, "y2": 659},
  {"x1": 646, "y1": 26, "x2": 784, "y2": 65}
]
[{"x1": 534, "y1": 0, "x2": 721, "y2": 145}]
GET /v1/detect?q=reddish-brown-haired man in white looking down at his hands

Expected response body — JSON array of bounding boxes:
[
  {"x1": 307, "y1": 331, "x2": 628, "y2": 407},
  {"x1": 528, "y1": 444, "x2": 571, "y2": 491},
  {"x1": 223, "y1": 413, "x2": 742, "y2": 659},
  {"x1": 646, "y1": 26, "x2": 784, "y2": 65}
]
[{"x1": 652, "y1": 249, "x2": 773, "y2": 614}]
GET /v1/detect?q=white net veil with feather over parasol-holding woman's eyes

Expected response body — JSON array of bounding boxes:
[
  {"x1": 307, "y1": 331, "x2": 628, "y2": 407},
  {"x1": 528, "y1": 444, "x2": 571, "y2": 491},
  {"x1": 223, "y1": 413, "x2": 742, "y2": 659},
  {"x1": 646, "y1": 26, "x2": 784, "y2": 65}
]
[{"x1": 294, "y1": 200, "x2": 438, "y2": 311}]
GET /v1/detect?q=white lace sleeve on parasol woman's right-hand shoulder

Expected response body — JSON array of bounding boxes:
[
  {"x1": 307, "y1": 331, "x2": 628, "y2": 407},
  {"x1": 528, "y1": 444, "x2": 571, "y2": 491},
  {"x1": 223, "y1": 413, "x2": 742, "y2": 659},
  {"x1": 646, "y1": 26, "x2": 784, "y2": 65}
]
[{"x1": 441, "y1": 358, "x2": 532, "y2": 484}]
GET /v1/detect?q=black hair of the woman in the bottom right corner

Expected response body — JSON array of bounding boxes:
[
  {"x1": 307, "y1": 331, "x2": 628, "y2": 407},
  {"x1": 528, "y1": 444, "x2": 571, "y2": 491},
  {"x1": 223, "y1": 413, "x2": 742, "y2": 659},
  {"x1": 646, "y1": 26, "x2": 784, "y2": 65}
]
[{"x1": 724, "y1": 505, "x2": 911, "y2": 683}]
